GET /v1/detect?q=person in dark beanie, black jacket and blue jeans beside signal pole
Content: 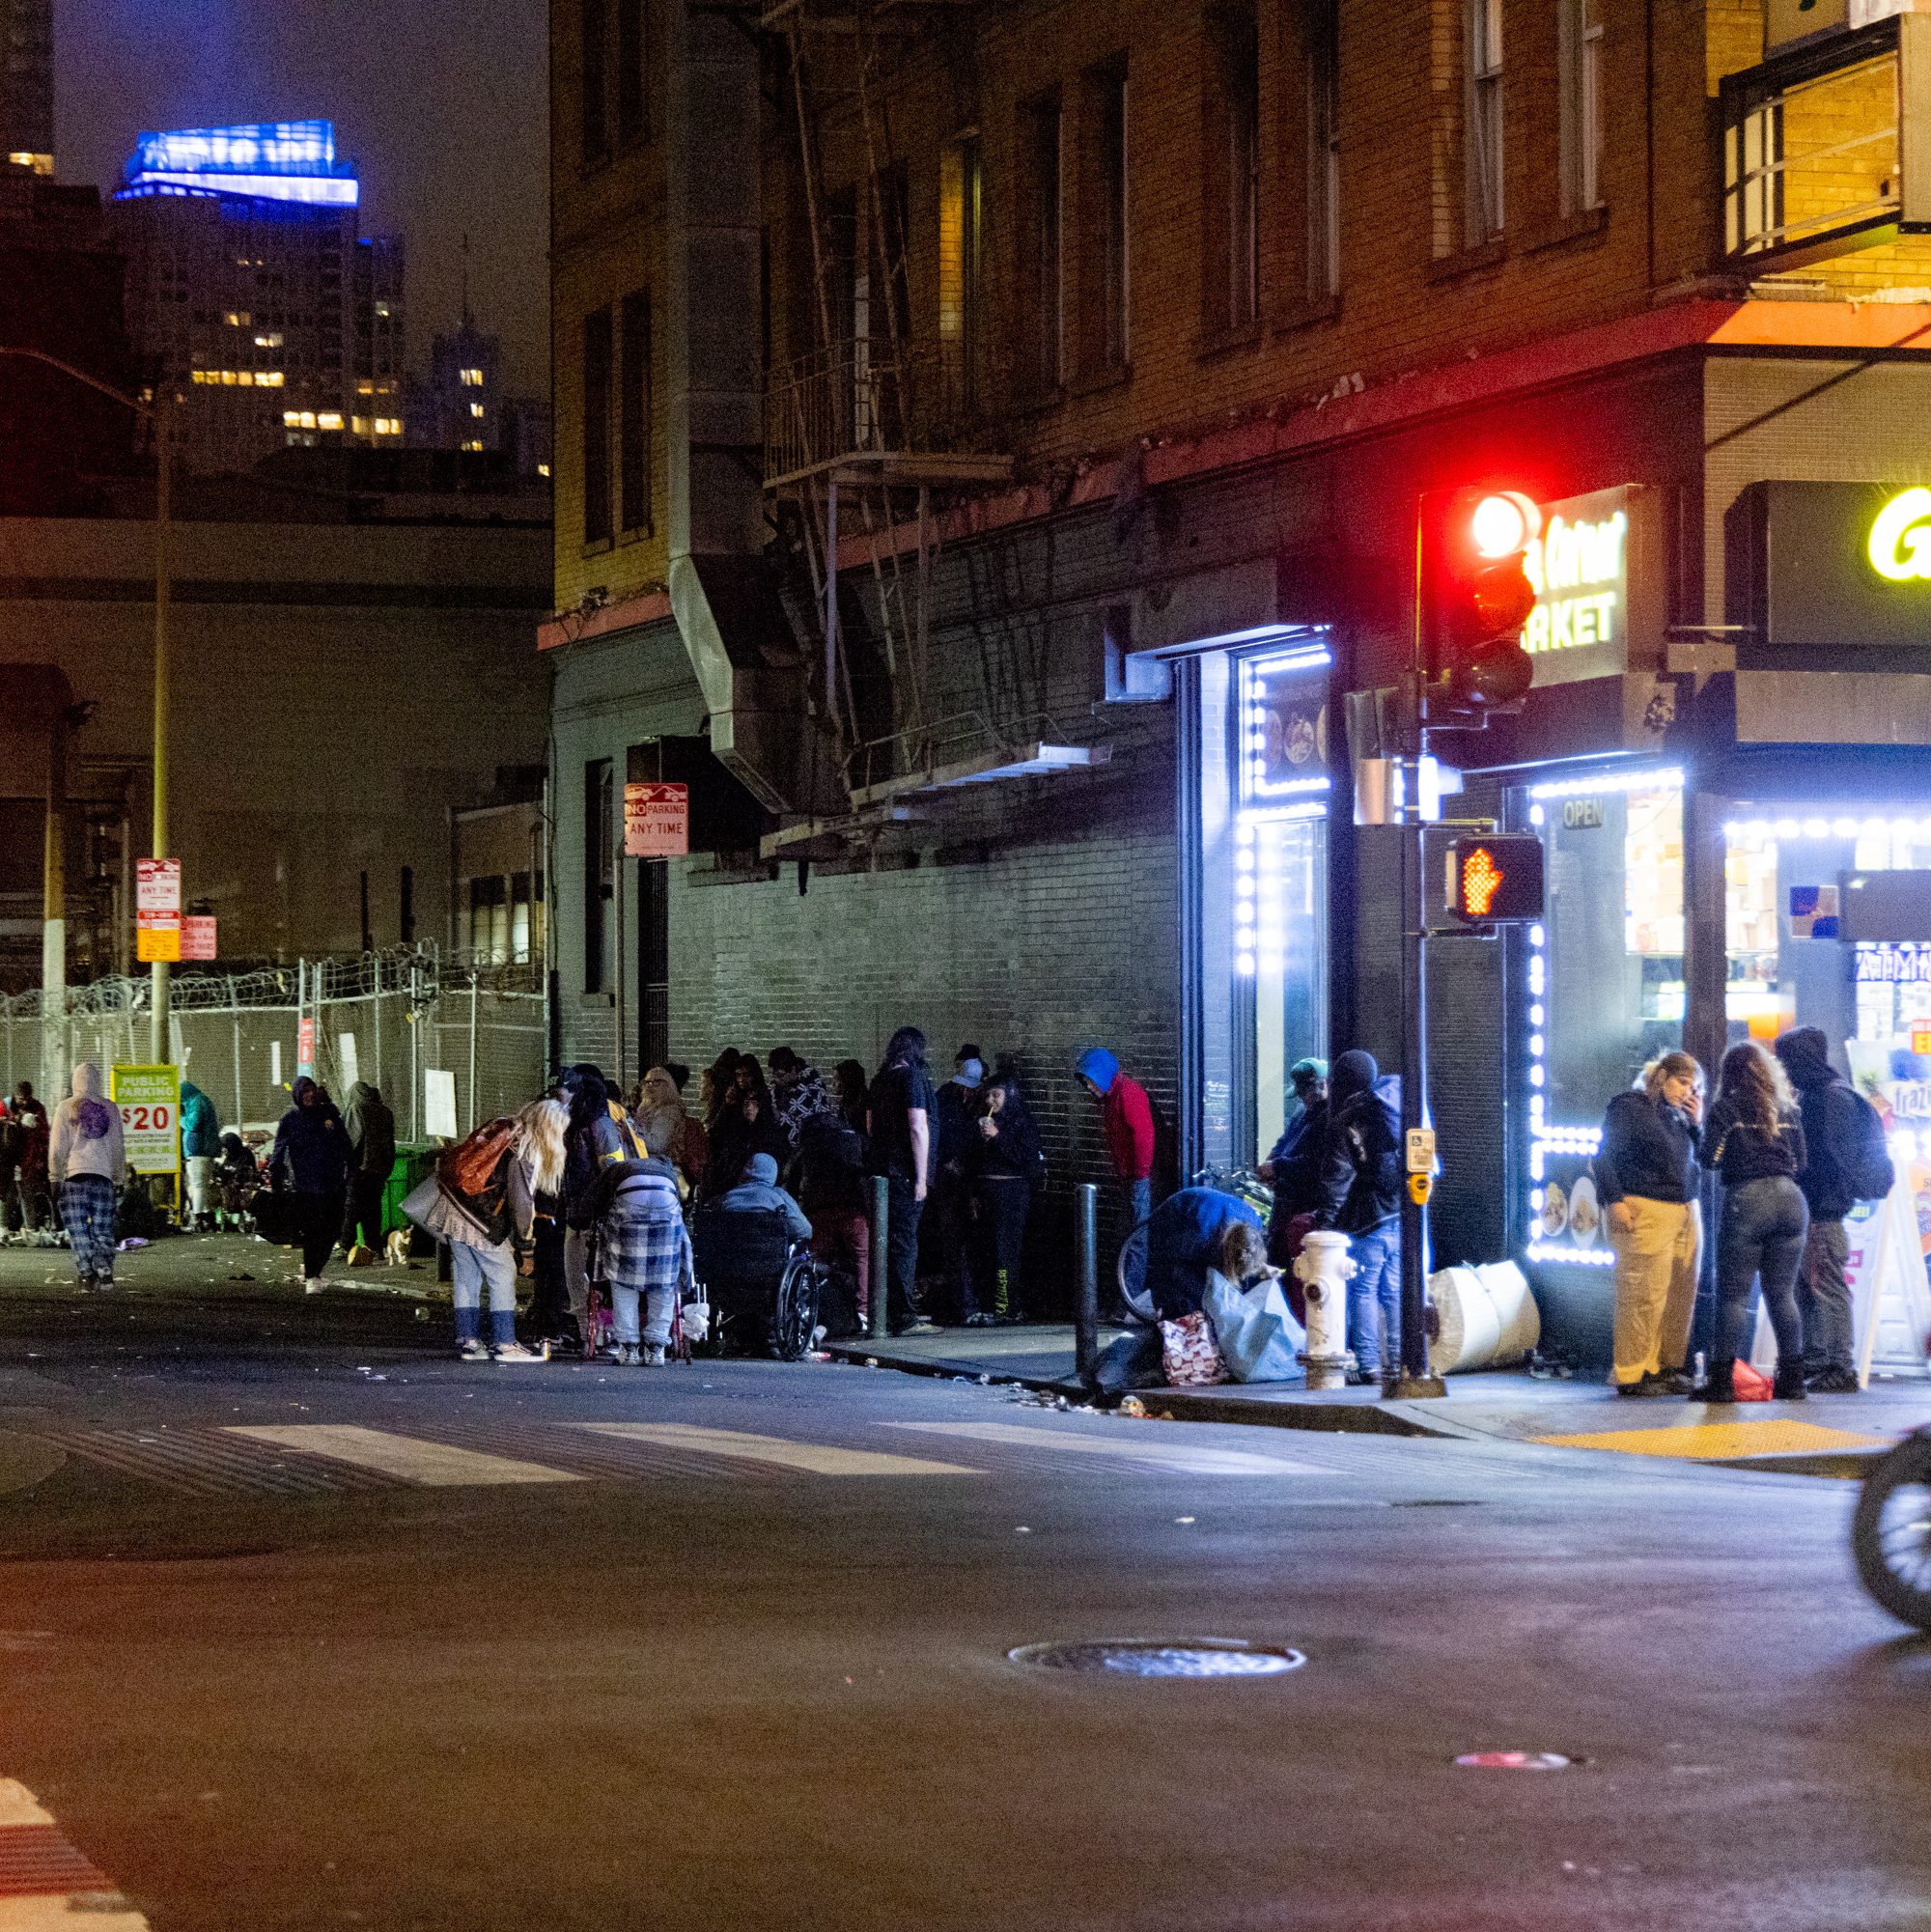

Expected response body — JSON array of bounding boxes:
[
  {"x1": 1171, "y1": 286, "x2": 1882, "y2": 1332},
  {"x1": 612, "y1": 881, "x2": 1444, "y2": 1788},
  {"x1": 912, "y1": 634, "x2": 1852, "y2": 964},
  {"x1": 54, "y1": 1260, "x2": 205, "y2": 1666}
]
[{"x1": 1315, "y1": 1048, "x2": 1402, "y2": 1384}]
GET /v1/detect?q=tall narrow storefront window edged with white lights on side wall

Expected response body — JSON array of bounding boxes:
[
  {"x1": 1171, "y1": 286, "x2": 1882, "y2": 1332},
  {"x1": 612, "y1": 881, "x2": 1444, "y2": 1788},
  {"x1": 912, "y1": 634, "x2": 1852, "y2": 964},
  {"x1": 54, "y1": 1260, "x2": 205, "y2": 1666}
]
[{"x1": 1201, "y1": 641, "x2": 1332, "y2": 1167}]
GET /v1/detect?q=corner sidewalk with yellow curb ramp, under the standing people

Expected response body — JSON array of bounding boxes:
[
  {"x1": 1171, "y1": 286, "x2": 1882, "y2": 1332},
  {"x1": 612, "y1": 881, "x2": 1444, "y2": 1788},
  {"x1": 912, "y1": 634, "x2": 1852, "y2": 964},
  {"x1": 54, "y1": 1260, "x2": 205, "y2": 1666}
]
[{"x1": 830, "y1": 1324, "x2": 1931, "y2": 1476}]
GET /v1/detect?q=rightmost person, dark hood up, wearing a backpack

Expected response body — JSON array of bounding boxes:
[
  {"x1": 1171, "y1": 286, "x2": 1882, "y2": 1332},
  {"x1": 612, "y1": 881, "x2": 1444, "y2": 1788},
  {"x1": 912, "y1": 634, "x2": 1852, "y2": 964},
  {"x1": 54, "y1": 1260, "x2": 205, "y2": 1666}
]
[{"x1": 1777, "y1": 1026, "x2": 1896, "y2": 1395}]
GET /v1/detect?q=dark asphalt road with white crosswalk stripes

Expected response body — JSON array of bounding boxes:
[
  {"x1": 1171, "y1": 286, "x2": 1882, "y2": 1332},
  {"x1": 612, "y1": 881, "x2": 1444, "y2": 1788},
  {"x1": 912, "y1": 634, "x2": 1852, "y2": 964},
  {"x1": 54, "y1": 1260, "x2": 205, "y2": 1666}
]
[{"x1": 0, "y1": 1254, "x2": 1931, "y2": 1932}]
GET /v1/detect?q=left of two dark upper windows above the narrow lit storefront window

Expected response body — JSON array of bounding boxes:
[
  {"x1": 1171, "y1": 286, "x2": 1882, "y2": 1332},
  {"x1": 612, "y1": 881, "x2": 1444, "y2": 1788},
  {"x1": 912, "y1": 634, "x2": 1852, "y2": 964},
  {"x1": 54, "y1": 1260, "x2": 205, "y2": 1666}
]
[{"x1": 1201, "y1": 6, "x2": 1261, "y2": 330}]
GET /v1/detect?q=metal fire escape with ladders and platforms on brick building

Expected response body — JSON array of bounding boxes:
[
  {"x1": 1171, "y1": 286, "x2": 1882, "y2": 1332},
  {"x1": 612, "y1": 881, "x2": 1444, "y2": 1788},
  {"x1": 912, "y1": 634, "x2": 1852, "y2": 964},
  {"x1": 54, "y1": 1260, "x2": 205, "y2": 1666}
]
[{"x1": 763, "y1": 0, "x2": 1089, "y2": 855}]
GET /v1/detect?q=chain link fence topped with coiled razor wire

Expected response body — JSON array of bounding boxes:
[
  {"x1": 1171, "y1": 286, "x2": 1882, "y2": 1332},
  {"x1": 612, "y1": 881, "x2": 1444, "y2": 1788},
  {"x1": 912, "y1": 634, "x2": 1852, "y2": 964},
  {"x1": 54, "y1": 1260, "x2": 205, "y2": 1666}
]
[{"x1": 0, "y1": 946, "x2": 548, "y2": 1140}]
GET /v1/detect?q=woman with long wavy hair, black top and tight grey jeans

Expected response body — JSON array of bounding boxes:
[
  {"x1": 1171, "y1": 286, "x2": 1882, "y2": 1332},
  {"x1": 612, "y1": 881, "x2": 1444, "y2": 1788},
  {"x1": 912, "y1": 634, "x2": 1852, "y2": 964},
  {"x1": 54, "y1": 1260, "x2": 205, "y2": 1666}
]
[{"x1": 1703, "y1": 1040, "x2": 1809, "y2": 1403}]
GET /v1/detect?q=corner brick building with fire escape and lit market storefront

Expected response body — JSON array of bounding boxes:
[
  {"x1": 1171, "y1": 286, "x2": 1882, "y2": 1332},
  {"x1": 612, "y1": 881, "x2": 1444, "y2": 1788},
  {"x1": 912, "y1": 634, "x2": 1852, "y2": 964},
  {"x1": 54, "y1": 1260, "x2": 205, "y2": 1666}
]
[{"x1": 543, "y1": 0, "x2": 1931, "y2": 1358}]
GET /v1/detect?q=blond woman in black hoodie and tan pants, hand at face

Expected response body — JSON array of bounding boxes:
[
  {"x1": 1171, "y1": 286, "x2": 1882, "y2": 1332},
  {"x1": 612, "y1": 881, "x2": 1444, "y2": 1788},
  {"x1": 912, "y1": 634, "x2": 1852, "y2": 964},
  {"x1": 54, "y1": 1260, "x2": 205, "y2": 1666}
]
[{"x1": 1595, "y1": 1053, "x2": 1703, "y2": 1397}]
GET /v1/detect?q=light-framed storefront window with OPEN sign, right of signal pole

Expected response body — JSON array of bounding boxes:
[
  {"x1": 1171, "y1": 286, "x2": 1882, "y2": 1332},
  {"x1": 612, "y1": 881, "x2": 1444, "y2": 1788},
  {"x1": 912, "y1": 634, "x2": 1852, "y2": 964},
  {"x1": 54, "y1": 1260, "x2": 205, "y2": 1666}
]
[{"x1": 1518, "y1": 769, "x2": 1686, "y2": 1268}]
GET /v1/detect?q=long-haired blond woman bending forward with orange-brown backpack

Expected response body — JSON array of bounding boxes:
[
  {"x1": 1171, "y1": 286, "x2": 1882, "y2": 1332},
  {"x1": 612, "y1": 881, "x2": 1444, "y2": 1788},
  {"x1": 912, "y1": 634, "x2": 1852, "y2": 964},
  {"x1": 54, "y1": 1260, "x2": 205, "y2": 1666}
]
[{"x1": 404, "y1": 1100, "x2": 570, "y2": 1362}]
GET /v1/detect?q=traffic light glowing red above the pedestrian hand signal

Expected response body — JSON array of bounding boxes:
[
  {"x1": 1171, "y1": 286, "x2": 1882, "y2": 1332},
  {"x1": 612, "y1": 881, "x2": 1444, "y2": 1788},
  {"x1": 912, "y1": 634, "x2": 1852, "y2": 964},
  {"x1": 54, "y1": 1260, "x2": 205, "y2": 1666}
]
[{"x1": 1421, "y1": 490, "x2": 1543, "y2": 716}]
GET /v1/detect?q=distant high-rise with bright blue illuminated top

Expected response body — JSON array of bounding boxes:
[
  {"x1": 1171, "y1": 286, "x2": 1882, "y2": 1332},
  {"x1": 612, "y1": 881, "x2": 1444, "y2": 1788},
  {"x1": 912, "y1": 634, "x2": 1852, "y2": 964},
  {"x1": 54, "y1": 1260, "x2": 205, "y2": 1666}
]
[{"x1": 114, "y1": 122, "x2": 404, "y2": 473}]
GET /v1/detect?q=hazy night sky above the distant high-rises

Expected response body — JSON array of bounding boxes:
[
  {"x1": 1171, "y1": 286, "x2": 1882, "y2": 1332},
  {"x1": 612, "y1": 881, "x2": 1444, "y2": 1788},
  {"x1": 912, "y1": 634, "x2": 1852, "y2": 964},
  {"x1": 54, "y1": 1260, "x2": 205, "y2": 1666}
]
[{"x1": 56, "y1": 0, "x2": 548, "y2": 394}]
